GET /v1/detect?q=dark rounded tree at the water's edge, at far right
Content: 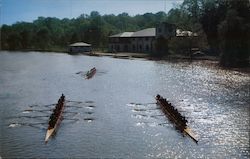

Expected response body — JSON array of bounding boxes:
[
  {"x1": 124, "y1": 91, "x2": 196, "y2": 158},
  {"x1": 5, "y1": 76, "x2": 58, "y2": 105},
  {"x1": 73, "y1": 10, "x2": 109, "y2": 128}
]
[{"x1": 219, "y1": 9, "x2": 250, "y2": 67}]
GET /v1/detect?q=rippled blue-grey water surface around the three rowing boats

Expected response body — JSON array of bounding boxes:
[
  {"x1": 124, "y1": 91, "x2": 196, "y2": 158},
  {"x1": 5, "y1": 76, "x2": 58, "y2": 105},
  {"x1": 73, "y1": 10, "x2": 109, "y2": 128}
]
[{"x1": 0, "y1": 51, "x2": 250, "y2": 158}]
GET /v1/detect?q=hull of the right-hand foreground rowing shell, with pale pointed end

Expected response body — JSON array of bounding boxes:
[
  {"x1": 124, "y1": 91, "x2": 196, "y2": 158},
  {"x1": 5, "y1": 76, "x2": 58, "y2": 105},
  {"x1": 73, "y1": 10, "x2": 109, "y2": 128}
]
[{"x1": 156, "y1": 98, "x2": 198, "y2": 143}]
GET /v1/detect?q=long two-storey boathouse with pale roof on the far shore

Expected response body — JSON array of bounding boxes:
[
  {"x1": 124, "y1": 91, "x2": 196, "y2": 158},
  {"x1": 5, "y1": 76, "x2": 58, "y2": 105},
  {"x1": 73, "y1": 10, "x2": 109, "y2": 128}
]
[{"x1": 109, "y1": 23, "x2": 176, "y2": 53}]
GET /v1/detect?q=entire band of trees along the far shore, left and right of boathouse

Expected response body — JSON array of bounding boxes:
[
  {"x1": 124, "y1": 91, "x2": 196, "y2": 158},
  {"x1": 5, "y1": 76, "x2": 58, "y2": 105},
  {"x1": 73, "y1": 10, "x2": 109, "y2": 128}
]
[{"x1": 1, "y1": 0, "x2": 250, "y2": 67}]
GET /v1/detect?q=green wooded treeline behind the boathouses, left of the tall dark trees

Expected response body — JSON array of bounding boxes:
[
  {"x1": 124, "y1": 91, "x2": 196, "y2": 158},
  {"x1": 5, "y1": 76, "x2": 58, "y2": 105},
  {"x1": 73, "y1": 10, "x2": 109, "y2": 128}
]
[{"x1": 1, "y1": 11, "x2": 167, "y2": 50}]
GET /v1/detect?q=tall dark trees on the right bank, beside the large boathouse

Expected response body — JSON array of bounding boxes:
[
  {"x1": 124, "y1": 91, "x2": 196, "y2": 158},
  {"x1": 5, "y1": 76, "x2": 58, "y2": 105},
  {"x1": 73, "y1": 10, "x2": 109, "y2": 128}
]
[{"x1": 168, "y1": 0, "x2": 250, "y2": 67}]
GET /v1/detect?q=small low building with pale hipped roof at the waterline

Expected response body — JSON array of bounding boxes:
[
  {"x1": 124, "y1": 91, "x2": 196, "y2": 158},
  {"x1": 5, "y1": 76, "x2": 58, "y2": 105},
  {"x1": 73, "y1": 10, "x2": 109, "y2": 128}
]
[{"x1": 69, "y1": 42, "x2": 92, "y2": 53}]
